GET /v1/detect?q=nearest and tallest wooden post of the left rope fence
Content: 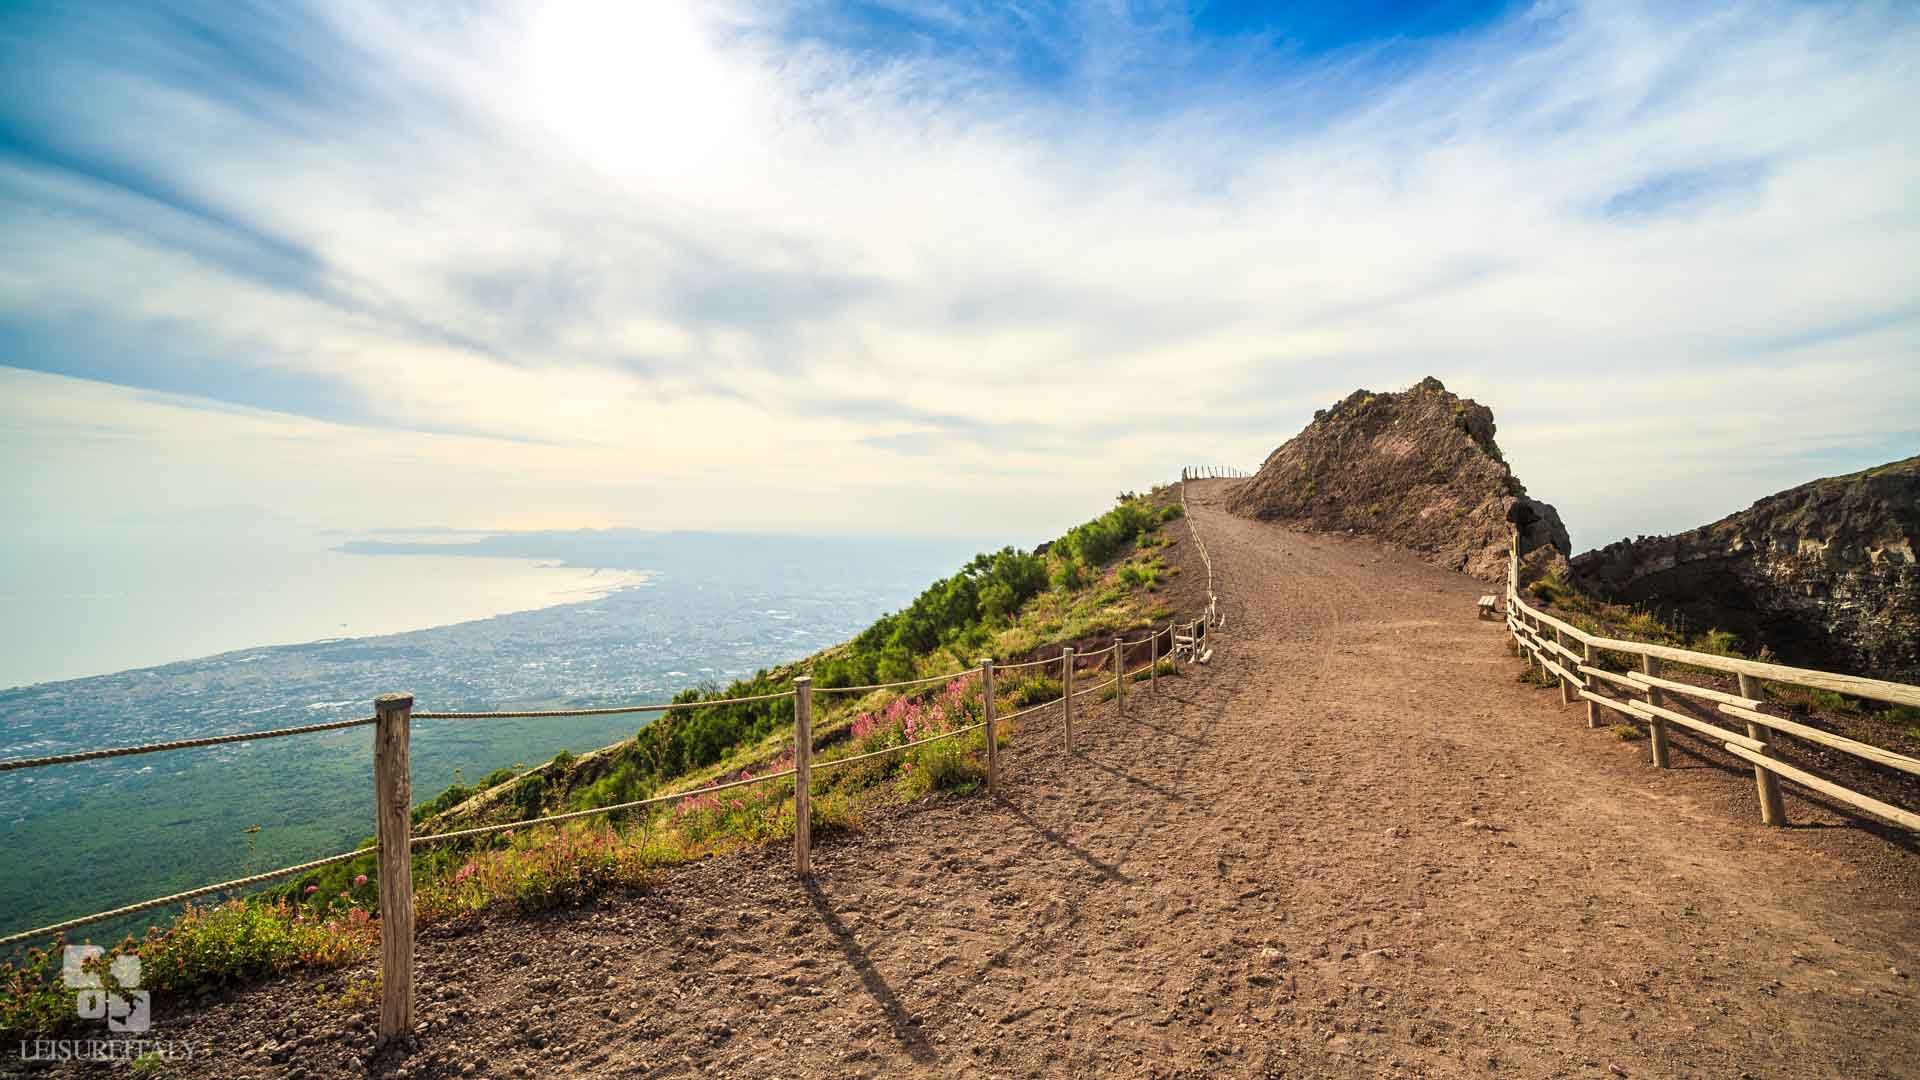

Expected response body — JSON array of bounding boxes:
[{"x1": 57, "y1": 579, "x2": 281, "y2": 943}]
[{"x1": 372, "y1": 694, "x2": 413, "y2": 1043}]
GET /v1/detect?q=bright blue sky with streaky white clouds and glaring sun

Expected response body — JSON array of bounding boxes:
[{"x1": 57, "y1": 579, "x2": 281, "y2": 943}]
[{"x1": 0, "y1": 0, "x2": 1920, "y2": 548}]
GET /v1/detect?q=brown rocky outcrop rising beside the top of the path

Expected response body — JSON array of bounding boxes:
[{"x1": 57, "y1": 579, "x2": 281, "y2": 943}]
[{"x1": 1227, "y1": 379, "x2": 1569, "y2": 582}]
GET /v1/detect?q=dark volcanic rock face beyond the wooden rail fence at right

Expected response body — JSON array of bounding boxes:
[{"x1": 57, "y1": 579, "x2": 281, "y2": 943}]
[{"x1": 1572, "y1": 457, "x2": 1920, "y2": 682}]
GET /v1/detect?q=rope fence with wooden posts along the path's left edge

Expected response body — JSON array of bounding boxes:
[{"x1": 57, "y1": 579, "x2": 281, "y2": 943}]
[{"x1": 0, "y1": 469, "x2": 1217, "y2": 1042}]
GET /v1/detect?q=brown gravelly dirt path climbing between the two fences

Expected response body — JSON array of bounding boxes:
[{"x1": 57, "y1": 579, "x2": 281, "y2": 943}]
[{"x1": 67, "y1": 484, "x2": 1920, "y2": 1078}]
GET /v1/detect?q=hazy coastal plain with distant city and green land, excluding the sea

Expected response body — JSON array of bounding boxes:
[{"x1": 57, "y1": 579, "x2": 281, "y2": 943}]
[{"x1": 0, "y1": 530, "x2": 979, "y2": 930}]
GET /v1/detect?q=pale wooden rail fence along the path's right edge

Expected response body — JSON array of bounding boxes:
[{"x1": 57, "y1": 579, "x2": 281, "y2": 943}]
[{"x1": 1507, "y1": 528, "x2": 1920, "y2": 832}]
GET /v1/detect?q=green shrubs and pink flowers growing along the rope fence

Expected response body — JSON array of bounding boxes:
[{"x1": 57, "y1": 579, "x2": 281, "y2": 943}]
[{"x1": 0, "y1": 494, "x2": 1181, "y2": 1036}]
